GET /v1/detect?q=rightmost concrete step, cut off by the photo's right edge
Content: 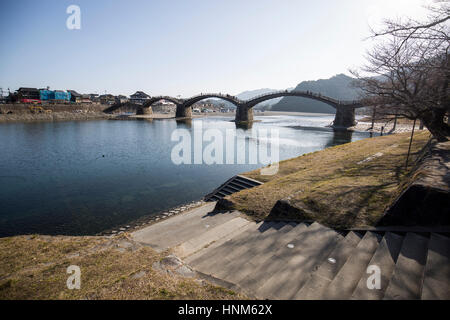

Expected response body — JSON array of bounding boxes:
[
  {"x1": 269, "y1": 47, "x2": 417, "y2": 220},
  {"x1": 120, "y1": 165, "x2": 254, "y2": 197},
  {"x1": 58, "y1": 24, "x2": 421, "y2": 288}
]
[{"x1": 422, "y1": 233, "x2": 450, "y2": 300}]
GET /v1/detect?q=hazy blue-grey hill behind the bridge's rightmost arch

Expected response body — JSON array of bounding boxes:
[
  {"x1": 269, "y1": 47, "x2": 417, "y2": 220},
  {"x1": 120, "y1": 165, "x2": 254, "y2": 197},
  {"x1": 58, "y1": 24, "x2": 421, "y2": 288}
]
[{"x1": 272, "y1": 74, "x2": 358, "y2": 113}]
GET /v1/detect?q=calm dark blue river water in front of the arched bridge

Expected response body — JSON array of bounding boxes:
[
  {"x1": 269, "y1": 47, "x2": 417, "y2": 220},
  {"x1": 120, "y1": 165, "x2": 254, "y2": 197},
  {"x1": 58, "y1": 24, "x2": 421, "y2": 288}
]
[{"x1": 0, "y1": 115, "x2": 368, "y2": 237}]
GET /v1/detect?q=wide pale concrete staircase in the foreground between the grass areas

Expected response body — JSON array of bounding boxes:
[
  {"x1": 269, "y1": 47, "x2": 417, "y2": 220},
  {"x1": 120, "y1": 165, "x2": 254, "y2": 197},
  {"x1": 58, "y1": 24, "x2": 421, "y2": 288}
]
[{"x1": 133, "y1": 203, "x2": 450, "y2": 300}]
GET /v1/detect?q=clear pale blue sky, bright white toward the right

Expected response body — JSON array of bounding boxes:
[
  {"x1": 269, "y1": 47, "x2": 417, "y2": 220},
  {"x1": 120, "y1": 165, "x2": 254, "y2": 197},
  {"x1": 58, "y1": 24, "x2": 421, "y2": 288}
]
[{"x1": 0, "y1": 0, "x2": 423, "y2": 97}]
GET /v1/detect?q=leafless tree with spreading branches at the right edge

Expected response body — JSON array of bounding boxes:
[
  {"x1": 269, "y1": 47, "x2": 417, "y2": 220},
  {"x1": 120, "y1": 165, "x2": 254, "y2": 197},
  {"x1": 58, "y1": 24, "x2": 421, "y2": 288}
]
[{"x1": 352, "y1": 2, "x2": 450, "y2": 141}]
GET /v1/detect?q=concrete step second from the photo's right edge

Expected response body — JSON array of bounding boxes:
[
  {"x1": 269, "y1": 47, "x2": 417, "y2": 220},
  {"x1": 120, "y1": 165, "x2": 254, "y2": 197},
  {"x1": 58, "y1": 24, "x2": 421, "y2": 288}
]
[{"x1": 384, "y1": 233, "x2": 428, "y2": 300}]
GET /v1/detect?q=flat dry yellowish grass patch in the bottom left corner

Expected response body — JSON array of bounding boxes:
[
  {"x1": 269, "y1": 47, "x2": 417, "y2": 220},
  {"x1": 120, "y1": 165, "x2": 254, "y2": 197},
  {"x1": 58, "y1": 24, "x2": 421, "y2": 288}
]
[{"x1": 0, "y1": 236, "x2": 242, "y2": 299}]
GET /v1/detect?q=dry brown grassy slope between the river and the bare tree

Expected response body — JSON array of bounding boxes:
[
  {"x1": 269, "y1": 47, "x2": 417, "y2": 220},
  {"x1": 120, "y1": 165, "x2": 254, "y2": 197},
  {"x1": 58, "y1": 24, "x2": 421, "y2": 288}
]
[{"x1": 227, "y1": 131, "x2": 430, "y2": 228}]
